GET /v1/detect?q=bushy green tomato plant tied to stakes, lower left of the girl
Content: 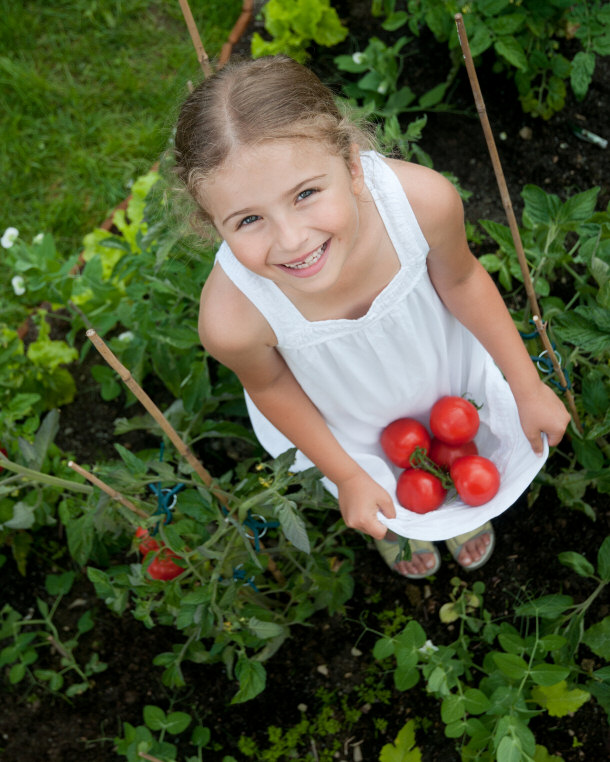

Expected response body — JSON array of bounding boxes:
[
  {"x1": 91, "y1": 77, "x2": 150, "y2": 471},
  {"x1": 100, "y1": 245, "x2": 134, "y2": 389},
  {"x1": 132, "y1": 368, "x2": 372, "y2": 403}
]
[{"x1": 60, "y1": 445, "x2": 353, "y2": 703}]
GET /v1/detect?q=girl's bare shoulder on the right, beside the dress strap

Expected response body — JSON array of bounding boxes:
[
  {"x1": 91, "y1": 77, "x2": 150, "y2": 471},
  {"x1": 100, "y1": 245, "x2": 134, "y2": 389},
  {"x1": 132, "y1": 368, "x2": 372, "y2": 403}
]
[{"x1": 386, "y1": 159, "x2": 464, "y2": 247}]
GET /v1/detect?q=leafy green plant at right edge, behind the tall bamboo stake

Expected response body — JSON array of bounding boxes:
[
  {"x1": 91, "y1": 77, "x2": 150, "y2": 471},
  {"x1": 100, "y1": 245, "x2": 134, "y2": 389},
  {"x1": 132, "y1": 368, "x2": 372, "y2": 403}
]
[{"x1": 480, "y1": 185, "x2": 610, "y2": 518}]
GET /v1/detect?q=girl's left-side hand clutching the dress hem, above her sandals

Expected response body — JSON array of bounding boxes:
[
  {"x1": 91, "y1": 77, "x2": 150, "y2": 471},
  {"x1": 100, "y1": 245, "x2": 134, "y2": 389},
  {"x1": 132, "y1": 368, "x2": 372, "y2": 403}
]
[{"x1": 337, "y1": 471, "x2": 396, "y2": 540}]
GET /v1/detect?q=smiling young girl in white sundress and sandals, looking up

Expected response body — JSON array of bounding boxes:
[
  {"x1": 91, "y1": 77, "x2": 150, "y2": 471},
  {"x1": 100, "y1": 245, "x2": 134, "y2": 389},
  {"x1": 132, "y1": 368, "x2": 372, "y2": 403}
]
[{"x1": 175, "y1": 56, "x2": 569, "y2": 578}]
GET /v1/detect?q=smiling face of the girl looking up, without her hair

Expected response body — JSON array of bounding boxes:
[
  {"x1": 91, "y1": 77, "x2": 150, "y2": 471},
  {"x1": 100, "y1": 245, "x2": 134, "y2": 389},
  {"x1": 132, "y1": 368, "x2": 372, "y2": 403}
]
[{"x1": 202, "y1": 139, "x2": 364, "y2": 293}]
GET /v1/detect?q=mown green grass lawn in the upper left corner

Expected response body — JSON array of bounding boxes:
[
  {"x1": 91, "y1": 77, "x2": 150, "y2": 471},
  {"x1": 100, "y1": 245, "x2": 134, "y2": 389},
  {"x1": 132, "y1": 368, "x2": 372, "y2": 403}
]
[{"x1": 0, "y1": 0, "x2": 242, "y2": 255}]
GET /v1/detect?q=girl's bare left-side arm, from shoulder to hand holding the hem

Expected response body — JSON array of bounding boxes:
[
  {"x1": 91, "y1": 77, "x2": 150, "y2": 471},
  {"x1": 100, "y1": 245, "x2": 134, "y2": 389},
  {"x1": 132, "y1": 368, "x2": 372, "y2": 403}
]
[{"x1": 199, "y1": 269, "x2": 396, "y2": 539}]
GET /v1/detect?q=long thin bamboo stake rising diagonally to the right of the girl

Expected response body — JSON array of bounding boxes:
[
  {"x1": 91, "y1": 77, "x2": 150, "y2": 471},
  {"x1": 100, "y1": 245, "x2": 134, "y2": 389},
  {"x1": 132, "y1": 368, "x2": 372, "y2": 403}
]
[{"x1": 454, "y1": 13, "x2": 583, "y2": 434}]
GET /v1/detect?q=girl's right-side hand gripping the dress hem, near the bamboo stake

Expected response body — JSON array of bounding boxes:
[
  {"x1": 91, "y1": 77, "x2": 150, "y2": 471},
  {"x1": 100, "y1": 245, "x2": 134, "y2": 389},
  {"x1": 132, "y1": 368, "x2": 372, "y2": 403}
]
[{"x1": 517, "y1": 381, "x2": 570, "y2": 455}]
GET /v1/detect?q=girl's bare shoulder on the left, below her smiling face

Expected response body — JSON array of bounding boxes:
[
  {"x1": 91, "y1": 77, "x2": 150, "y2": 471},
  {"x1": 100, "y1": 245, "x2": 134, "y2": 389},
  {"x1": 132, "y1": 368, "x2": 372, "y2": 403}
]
[{"x1": 199, "y1": 264, "x2": 276, "y2": 369}]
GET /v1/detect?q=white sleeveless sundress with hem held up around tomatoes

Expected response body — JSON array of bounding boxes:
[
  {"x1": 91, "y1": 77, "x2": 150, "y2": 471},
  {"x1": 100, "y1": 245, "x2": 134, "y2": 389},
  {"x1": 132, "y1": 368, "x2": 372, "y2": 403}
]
[{"x1": 217, "y1": 152, "x2": 548, "y2": 541}]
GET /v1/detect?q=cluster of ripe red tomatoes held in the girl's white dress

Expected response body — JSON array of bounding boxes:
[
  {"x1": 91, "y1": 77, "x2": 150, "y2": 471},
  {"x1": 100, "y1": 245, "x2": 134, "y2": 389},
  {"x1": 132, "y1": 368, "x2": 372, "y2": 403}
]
[{"x1": 381, "y1": 396, "x2": 500, "y2": 513}]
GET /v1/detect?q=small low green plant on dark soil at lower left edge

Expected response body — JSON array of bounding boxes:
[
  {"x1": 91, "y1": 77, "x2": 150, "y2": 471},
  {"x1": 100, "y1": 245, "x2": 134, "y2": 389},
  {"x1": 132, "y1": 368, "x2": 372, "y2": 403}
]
[{"x1": 0, "y1": 572, "x2": 107, "y2": 698}]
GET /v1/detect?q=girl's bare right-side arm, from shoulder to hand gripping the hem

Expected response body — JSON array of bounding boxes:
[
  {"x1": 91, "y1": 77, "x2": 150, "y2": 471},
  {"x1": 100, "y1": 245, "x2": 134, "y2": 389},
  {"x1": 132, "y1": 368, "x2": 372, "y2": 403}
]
[{"x1": 393, "y1": 157, "x2": 570, "y2": 454}]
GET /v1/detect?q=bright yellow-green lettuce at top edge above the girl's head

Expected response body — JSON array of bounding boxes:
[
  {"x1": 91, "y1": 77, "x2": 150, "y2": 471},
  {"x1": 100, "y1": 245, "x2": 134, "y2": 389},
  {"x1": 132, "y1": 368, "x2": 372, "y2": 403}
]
[{"x1": 252, "y1": 0, "x2": 348, "y2": 63}]
